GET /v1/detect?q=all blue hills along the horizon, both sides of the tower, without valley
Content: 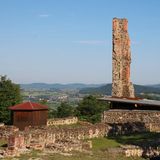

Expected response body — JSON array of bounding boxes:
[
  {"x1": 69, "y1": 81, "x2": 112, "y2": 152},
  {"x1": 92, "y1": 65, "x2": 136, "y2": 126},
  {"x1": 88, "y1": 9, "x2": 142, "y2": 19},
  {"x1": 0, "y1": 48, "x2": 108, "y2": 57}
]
[{"x1": 20, "y1": 83, "x2": 160, "y2": 95}]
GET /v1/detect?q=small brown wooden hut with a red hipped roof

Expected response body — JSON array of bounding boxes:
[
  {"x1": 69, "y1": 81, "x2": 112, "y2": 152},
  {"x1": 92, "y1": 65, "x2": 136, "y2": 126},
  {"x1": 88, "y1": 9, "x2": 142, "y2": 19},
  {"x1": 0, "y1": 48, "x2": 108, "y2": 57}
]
[{"x1": 9, "y1": 102, "x2": 48, "y2": 130}]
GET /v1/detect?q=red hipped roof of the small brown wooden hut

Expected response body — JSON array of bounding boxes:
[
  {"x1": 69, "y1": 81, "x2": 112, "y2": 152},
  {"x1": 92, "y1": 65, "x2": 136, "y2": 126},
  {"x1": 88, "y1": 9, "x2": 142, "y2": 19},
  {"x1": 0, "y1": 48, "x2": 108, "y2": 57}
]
[{"x1": 9, "y1": 102, "x2": 48, "y2": 110}]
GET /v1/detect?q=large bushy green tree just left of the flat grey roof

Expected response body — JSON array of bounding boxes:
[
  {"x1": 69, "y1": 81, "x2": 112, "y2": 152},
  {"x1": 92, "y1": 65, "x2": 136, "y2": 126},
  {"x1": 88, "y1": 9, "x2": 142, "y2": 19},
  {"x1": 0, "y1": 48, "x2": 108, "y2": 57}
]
[{"x1": 77, "y1": 95, "x2": 108, "y2": 123}]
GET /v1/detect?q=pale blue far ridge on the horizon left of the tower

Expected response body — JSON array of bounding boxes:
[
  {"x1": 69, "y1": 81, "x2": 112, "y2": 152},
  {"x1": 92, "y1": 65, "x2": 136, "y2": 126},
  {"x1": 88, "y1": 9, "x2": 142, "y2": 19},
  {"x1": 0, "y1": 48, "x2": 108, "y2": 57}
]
[{"x1": 20, "y1": 83, "x2": 103, "y2": 90}]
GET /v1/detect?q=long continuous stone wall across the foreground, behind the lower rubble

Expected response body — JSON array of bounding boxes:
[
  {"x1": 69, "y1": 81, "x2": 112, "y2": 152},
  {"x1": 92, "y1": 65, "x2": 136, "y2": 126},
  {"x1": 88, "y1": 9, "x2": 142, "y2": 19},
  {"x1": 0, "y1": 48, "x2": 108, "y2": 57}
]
[{"x1": 24, "y1": 123, "x2": 106, "y2": 144}]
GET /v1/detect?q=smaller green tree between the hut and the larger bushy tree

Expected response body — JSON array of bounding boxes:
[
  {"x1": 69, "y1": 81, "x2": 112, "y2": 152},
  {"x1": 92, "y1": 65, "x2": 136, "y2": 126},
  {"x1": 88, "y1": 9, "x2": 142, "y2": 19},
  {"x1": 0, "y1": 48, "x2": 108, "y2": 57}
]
[{"x1": 57, "y1": 102, "x2": 75, "y2": 118}]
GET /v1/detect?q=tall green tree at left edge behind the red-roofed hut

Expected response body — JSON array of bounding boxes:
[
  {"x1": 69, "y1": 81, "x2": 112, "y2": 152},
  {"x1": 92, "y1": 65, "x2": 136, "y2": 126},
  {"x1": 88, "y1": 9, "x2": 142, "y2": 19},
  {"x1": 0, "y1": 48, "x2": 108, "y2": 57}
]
[{"x1": 0, "y1": 76, "x2": 22, "y2": 123}]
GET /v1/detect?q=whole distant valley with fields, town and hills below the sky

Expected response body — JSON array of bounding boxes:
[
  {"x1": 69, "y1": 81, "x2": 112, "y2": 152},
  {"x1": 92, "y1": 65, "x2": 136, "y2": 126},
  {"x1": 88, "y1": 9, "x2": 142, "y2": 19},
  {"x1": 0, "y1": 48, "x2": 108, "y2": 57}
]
[{"x1": 20, "y1": 83, "x2": 160, "y2": 103}]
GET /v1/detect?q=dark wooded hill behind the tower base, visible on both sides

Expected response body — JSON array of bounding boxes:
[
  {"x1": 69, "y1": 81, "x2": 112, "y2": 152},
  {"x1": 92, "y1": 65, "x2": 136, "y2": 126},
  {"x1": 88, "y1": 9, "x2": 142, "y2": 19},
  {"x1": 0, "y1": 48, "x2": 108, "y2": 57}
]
[{"x1": 79, "y1": 84, "x2": 160, "y2": 95}]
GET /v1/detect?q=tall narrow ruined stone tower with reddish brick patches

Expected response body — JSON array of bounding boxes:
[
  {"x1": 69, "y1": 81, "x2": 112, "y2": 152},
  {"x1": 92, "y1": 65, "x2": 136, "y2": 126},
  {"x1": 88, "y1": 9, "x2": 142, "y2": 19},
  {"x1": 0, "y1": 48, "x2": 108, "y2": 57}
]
[{"x1": 112, "y1": 18, "x2": 134, "y2": 98}]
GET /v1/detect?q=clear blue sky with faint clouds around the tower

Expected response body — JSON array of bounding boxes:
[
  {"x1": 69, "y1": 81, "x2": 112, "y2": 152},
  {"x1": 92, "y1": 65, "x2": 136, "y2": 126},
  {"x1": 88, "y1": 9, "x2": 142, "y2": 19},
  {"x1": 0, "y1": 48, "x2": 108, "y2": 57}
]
[{"x1": 0, "y1": 0, "x2": 160, "y2": 84}]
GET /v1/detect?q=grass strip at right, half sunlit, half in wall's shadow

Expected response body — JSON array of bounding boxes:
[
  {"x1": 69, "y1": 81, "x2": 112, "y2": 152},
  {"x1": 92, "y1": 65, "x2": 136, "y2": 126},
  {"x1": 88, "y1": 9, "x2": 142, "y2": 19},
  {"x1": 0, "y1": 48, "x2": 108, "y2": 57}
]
[{"x1": 92, "y1": 132, "x2": 160, "y2": 150}]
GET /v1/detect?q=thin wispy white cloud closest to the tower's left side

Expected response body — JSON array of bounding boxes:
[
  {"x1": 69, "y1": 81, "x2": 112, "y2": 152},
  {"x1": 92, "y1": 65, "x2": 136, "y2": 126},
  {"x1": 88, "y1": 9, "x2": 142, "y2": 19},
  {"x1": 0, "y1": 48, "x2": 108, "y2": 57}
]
[{"x1": 73, "y1": 40, "x2": 107, "y2": 45}]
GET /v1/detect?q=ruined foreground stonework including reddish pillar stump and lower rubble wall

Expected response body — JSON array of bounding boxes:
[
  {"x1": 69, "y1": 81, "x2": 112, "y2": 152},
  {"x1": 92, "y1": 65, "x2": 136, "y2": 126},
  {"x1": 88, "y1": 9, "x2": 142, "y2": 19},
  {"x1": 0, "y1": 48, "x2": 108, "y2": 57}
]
[{"x1": 4, "y1": 124, "x2": 106, "y2": 155}]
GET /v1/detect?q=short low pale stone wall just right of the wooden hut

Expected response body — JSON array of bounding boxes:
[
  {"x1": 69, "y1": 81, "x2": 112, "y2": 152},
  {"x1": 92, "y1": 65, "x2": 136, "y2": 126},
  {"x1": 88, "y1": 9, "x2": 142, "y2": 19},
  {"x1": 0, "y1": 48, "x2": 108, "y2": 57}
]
[{"x1": 47, "y1": 117, "x2": 78, "y2": 126}]
